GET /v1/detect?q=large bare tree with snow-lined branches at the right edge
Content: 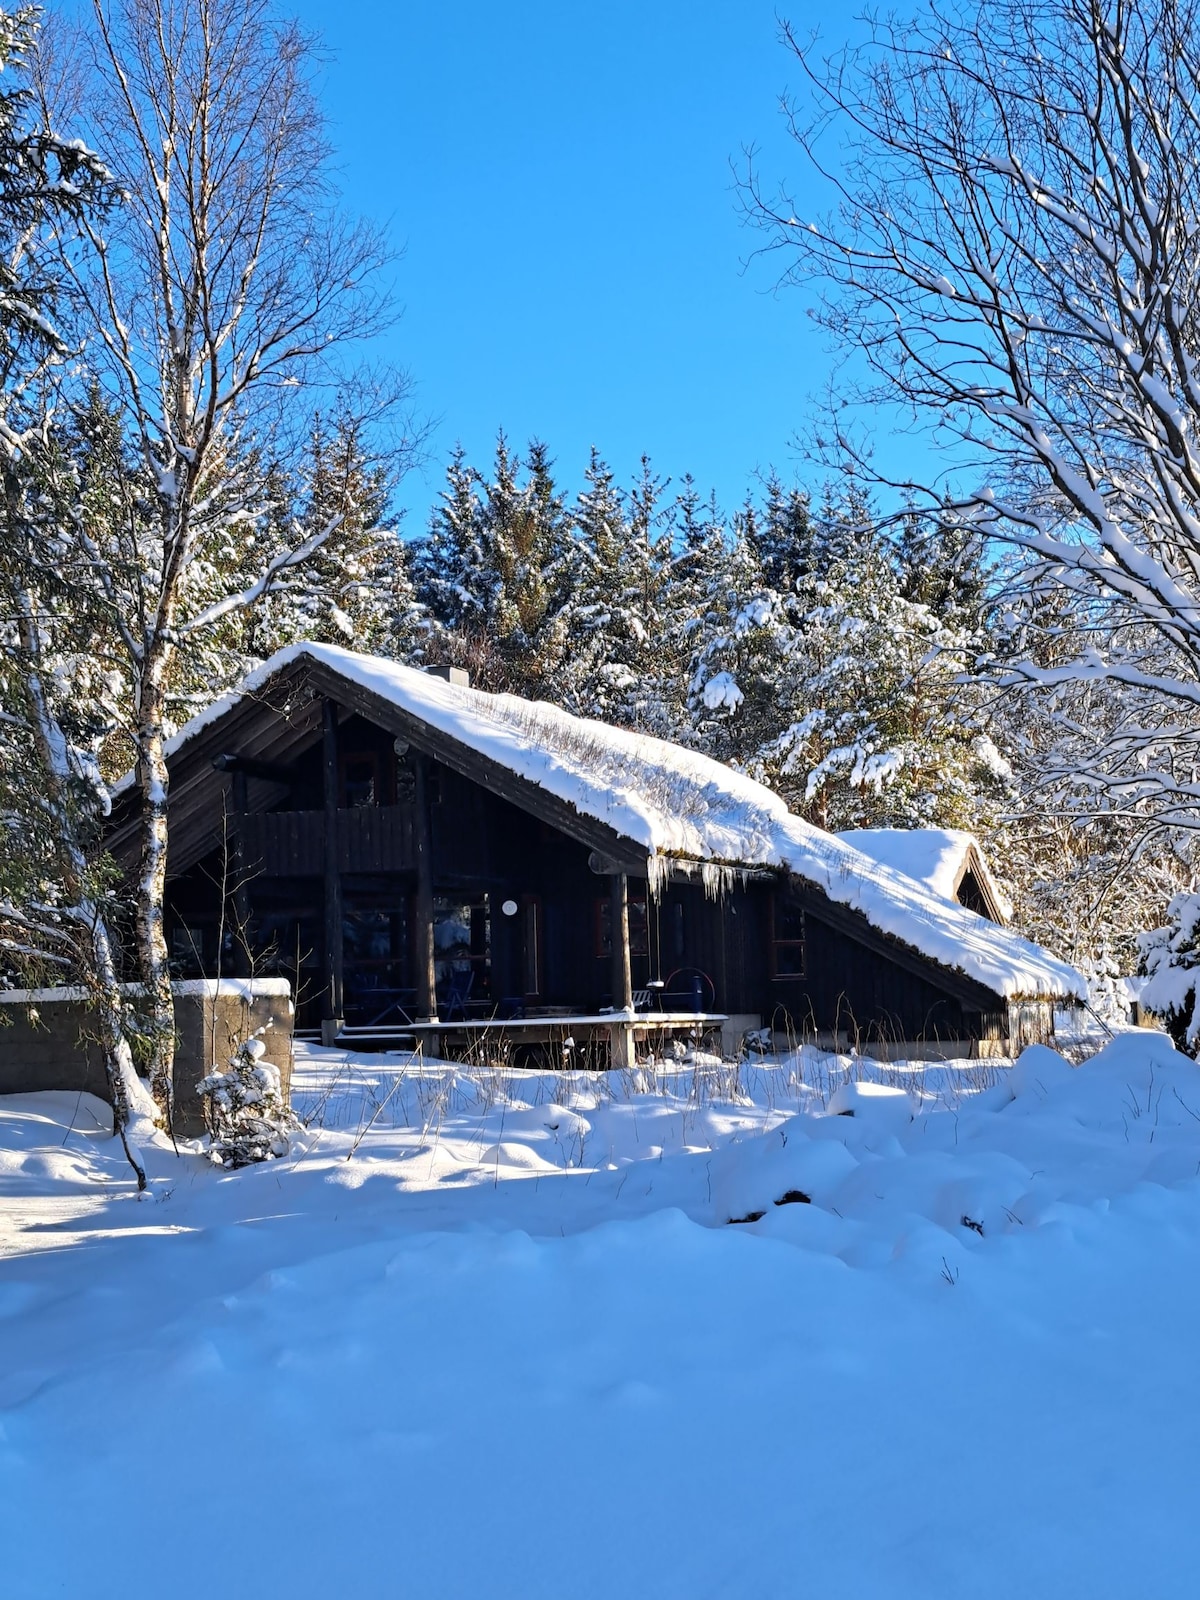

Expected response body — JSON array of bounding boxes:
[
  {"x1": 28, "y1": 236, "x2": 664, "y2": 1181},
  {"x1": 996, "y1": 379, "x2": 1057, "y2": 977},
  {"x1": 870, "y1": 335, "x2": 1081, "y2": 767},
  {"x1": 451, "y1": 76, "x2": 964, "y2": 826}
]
[{"x1": 746, "y1": 0, "x2": 1200, "y2": 851}]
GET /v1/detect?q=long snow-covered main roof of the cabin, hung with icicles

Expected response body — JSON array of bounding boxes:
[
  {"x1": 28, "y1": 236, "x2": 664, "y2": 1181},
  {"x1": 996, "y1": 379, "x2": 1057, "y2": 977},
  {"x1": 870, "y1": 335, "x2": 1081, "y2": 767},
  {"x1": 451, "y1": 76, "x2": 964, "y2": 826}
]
[{"x1": 143, "y1": 643, "x2": 1086, "y2": 998}]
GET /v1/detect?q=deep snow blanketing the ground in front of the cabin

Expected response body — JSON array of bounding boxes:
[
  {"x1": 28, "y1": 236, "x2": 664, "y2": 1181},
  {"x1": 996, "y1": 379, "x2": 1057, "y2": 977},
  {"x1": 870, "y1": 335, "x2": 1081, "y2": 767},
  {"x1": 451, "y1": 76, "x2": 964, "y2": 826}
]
[{"x1": 0, "y1": 1032, "x2": 1200, "y2": 1600}]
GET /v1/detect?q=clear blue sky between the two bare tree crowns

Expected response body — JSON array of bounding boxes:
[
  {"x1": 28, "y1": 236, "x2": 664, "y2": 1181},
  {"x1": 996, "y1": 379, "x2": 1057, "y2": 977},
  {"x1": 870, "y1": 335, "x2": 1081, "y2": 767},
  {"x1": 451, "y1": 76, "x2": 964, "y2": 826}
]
[{"x1": 291, "y1": 0, "x2": 846, "y2": 531}]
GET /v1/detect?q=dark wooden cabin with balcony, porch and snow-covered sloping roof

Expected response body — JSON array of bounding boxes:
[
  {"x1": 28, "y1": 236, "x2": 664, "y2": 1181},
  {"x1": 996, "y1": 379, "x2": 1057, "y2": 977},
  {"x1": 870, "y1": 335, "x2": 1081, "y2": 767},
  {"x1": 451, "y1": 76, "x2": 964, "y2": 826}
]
[{"x1": 101, "y1": 645, "x2": 1080, "y2": 1061}]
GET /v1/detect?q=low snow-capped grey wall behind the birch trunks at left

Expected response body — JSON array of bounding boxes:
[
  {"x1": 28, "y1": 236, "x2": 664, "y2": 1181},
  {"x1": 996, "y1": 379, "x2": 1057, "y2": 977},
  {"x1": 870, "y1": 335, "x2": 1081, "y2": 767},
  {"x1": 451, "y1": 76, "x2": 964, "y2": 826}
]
[{"x1": 0, "y1": 978, "x2": 293, "y2": 1138}]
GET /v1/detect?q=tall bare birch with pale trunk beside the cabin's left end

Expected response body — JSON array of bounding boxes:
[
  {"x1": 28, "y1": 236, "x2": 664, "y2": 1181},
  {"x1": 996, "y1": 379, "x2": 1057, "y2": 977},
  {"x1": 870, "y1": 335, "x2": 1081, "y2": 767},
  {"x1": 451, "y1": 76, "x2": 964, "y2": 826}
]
[{"x1": 43, "y1": 0, "x2": 403, "y2": 1107}]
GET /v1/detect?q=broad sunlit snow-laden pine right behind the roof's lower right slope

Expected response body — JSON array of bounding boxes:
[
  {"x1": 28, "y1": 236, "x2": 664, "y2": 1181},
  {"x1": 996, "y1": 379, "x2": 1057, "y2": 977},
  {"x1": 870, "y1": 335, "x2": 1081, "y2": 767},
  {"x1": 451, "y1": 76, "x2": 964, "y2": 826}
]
[{"x1": 691, "y1": 493, "x2": 1008, "y2": 829}]
